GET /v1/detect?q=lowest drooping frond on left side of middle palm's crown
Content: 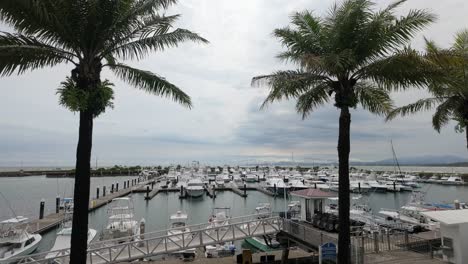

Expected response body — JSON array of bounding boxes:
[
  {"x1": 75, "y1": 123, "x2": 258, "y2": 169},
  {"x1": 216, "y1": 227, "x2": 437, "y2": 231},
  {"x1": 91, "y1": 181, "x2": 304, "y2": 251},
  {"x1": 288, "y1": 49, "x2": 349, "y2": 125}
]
[{"x1": 296, "y1": 83, "x2": 330, "y2": 119}]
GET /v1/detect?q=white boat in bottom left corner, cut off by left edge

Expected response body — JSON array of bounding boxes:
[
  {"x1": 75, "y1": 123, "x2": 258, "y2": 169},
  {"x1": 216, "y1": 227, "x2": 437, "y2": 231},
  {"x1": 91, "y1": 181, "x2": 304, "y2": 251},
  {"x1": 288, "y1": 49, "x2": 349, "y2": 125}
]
[{"x1": 0, "y1": 216, "x2": 42, "y2": 263}]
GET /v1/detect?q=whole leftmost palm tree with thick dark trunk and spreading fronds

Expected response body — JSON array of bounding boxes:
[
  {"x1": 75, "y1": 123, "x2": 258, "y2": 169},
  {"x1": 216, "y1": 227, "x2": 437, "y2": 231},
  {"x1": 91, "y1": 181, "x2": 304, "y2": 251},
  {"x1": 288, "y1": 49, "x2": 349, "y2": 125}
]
[{"x1": 0, "y1": 0, "x2": 207, "y2": 263}]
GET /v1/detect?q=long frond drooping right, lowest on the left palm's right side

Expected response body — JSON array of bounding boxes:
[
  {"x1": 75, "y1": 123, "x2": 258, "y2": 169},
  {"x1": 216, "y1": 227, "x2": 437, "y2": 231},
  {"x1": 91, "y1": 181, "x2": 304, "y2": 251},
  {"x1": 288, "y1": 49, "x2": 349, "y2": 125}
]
[{"x1": 108, "y1": 63, "x2": 192, "y2": 108}]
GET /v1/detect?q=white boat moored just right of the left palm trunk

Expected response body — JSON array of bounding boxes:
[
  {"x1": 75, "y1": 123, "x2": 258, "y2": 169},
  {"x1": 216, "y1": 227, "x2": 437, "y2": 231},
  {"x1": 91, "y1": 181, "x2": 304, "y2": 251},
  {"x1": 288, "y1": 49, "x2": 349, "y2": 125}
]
[{"x1": 101, "y1": 197, "x2": 140, "y2": 242}]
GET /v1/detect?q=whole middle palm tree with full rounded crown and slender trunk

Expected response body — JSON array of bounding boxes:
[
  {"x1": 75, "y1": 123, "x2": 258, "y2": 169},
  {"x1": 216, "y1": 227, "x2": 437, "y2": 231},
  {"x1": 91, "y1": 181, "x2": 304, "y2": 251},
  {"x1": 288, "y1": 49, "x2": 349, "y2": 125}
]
[{"x1": 252, "y1": 0, "x2": 435, "y2": 264}]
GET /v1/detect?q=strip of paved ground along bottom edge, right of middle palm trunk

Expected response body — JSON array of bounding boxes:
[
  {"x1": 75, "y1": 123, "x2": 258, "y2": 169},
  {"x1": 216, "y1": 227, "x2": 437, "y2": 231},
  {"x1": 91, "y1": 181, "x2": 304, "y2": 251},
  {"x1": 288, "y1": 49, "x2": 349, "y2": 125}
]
[{"x1": 365, "y1": 251, "x2": 447, "y2": 264}]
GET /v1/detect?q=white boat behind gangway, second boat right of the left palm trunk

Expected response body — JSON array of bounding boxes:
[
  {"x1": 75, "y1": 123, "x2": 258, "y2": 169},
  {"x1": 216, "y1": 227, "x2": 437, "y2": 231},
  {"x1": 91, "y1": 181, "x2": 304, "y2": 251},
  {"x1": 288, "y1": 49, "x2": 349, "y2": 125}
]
[{"x1": 167, "y1": 211, "x2": 196, "y2": 260}]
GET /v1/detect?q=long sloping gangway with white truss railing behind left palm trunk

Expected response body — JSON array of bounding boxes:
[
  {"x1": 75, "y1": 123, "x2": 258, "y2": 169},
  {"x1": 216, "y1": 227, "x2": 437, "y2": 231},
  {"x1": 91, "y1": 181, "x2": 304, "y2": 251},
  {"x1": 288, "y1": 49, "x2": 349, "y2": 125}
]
[{"x1": 4, "y1": 215, "x2": 283, "y2": 264}]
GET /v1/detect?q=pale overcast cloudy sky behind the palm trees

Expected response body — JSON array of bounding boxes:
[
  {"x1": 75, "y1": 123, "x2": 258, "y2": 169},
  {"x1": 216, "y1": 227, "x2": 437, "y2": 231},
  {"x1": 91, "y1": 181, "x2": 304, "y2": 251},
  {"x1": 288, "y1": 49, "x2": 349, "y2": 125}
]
[{"x1": 0, "y1": 0, "x2": 468, "y2": 166}]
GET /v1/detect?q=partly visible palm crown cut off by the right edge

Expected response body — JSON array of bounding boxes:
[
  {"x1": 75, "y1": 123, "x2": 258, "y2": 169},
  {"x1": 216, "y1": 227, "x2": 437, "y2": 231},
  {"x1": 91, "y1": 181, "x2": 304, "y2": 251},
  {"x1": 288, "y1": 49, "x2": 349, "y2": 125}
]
[{"x1": 387, "y1": 30, "x2": 468, "y2": 148}]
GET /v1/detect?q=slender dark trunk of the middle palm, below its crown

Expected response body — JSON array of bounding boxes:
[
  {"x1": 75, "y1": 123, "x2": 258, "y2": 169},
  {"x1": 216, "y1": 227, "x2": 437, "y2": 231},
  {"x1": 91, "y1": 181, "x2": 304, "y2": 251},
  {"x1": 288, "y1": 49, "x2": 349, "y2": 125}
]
[{"x1": 338, "y1": 106, "x2": 351, "y2": 264}]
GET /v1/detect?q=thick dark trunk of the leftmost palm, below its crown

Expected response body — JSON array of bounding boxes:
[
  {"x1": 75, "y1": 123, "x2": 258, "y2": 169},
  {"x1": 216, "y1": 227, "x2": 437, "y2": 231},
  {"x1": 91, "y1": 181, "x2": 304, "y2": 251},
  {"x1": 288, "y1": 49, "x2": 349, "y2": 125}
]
[{"x1": 70, "y1": 111, "x2": 93, "y2": 264}]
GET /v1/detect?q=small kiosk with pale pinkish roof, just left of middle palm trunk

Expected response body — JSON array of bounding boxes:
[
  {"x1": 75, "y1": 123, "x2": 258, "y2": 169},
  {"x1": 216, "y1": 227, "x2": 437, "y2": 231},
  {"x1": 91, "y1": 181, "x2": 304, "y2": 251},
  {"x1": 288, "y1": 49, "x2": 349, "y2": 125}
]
[{"x1": 290, "y1": 189, "x2": 337, "y2": 222}]
